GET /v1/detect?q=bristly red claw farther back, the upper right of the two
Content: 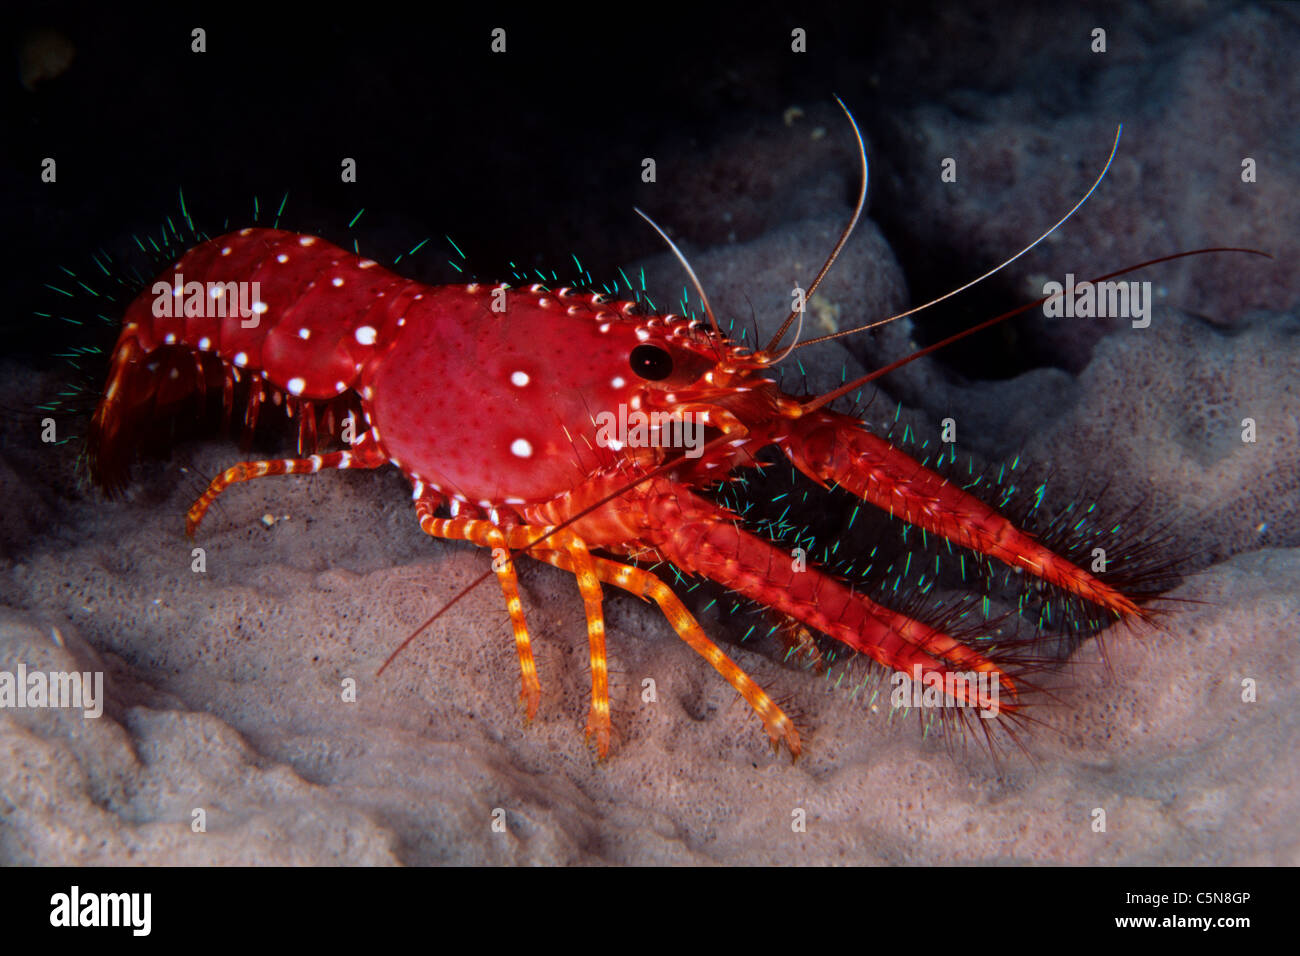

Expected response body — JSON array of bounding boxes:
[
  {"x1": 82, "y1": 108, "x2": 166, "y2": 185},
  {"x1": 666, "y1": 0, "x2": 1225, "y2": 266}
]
[{"x1": 784, "y1": 410, "x2": 1141, "y2": 617}]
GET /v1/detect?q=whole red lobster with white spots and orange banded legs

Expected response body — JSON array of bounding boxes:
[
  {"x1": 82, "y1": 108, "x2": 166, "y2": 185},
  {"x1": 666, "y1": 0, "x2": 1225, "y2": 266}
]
[{"x1": 88, "y1": 104, "x2": 1139, "y2": 756}]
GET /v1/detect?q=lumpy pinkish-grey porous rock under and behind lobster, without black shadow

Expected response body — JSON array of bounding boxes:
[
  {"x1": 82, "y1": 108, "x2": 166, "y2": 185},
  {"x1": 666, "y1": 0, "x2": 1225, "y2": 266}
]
[{"x1": 0, "y1": 3, "x2": 1300, "y2": 865}]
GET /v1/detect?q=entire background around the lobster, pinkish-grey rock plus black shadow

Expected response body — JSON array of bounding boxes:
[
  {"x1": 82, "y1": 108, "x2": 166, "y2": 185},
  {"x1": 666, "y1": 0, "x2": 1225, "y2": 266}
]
[{"x1": 0, "y1": 3, "x2": 1300, "y2": 864}]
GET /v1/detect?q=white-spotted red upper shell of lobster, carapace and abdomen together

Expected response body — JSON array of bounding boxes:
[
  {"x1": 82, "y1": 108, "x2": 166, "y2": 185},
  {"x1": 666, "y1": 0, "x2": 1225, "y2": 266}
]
[{"x1": 106, "y1": 229, "x2": 728, "y2": 506}]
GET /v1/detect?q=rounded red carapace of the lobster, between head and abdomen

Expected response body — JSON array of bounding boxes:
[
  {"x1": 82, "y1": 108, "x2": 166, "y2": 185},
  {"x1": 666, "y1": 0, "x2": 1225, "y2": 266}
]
[{"x1": 363, "y1": 285, "x2": 702, "y2": 505}]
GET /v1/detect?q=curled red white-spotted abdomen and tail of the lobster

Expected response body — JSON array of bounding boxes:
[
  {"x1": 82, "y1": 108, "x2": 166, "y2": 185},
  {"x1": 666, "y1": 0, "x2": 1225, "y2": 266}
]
[{"x1": 87, "y1": 229, "x2": 410, "y2": 489}]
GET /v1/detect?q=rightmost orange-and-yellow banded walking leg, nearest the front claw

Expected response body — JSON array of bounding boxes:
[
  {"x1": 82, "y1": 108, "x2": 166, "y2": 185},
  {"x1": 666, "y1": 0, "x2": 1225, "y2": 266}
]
[{"x1": 530, "y1": 545, "x2": 802, "y2": 757}]
